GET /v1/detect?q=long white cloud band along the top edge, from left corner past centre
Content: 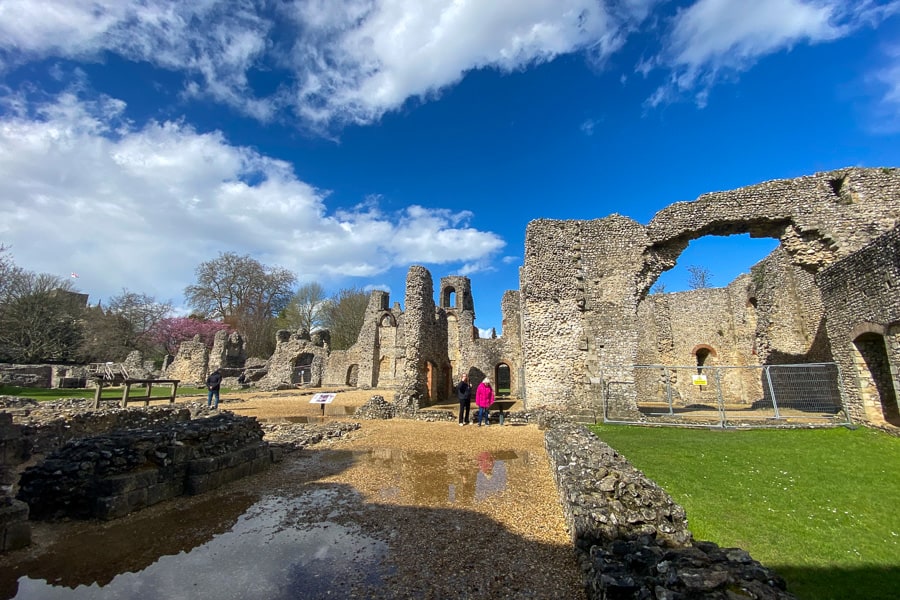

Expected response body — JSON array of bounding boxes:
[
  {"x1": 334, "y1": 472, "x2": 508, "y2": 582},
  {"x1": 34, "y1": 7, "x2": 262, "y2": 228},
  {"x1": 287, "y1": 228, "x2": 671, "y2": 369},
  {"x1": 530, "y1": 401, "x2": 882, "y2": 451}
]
[{"x1": 0, "y1": 0, "x2": 661, "y2": 126}]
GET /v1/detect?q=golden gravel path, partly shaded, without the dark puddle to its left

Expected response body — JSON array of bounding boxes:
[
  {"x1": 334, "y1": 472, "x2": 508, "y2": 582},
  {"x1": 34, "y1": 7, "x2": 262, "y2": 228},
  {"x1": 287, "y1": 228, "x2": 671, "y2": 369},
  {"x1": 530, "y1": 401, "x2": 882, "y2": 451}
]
[{"x1": 227, "y1": 391, "x2": 584, "y2": 599}]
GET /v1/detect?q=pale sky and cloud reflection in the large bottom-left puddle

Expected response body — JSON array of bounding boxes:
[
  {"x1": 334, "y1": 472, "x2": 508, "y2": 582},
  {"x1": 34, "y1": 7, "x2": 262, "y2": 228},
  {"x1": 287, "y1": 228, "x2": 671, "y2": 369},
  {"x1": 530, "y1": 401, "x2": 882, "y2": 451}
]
[{"x1": 3, "y1": 489, "x2": 386, "y2": 600}]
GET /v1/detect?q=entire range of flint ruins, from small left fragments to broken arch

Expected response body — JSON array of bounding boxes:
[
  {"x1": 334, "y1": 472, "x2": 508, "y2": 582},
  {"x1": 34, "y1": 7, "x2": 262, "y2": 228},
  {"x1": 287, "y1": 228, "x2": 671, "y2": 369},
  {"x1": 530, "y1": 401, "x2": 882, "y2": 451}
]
[{"x1": 148, "y1": 168, "x2": 900, "y2": 425}]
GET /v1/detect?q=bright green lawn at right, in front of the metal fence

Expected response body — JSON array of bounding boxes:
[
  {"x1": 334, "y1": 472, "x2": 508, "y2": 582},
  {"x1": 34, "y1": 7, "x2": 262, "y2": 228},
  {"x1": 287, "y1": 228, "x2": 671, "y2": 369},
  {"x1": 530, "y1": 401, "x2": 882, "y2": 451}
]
[{"x1": 592, "y1": 425, "x2": 900, "y2": 600}]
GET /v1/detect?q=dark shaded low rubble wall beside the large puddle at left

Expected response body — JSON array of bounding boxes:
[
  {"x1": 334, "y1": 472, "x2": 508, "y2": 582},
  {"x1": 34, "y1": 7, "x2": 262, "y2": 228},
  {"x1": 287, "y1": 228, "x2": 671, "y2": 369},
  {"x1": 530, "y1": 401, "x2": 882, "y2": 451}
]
[{"x1": 17, "y1": 413, "x2": 275, "y2": 519}]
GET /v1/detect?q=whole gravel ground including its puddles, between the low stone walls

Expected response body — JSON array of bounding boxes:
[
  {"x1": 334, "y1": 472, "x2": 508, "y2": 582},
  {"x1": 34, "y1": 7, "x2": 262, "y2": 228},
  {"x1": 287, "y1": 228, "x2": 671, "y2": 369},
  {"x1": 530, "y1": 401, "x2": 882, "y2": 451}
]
[{"x1": 0, "y1": 390, "x2": 584, "y2": 600}]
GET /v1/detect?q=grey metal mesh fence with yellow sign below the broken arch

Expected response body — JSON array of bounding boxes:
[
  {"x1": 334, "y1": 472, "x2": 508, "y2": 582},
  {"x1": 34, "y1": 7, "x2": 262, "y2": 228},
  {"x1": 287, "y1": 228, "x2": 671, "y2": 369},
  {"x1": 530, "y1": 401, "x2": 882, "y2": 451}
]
[{"x1": 602, "y1": 363, "x2": 849, "y2": 427}]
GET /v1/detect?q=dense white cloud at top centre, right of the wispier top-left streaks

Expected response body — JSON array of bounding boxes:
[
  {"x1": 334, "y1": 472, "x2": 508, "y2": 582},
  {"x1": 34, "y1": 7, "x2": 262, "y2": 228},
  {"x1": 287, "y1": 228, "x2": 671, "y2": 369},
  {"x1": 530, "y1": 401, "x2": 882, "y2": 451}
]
[{"x1": 295, "y1": 0, "x2": 652, "y2": 123}]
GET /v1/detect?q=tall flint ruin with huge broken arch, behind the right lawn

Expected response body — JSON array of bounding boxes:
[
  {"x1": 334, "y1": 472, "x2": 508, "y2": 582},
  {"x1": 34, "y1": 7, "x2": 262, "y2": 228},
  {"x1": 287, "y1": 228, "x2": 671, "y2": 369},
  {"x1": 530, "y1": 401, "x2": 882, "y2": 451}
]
[{"x1": 520, "y1": 168, "x2": 900, "y2": 424}]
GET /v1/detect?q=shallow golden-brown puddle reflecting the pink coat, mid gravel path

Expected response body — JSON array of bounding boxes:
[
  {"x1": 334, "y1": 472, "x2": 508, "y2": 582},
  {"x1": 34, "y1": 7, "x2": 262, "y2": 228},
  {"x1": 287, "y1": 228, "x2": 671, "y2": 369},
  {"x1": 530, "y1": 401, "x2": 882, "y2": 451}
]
[{"x1": 356, "y1": 448, "x2": 530, "y2": 506}]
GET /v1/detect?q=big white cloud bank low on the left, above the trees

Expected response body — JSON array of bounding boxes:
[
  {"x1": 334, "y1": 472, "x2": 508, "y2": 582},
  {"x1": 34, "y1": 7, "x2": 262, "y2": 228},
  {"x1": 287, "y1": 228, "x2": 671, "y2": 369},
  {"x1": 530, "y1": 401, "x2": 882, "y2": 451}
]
[{"x1": 0, "y1": 94, "x2": 504, "y2": 308}]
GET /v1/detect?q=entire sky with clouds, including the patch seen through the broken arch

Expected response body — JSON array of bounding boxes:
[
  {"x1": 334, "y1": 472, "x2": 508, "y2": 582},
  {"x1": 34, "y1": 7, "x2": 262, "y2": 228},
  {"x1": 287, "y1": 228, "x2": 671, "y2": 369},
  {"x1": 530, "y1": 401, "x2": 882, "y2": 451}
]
[{"x1": 0, "y1": 0, "x2": 900, "y2": 330}]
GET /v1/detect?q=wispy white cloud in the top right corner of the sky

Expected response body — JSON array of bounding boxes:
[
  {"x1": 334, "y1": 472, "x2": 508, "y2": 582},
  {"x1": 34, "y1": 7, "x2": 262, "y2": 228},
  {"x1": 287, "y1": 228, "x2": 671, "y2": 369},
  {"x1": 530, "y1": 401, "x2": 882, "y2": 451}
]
[{"x1": 637, "y1": 0, "x2": 900, "y2": 106}]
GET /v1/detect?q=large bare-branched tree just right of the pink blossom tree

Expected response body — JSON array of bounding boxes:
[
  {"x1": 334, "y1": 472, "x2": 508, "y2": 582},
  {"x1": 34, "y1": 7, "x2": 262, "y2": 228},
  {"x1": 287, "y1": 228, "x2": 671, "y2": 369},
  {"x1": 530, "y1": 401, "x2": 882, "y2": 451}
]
[{"x1": 184, "y1": 252, "x2": 297, "y2": 356}]
